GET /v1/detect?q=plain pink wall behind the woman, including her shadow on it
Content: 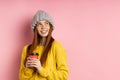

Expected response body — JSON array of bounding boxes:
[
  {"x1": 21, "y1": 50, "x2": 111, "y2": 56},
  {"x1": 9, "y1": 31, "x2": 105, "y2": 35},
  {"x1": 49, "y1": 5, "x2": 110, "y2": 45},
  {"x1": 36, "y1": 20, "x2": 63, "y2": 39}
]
[{"x1": 0, "y1": 0, "x2": 120, "y2": 80}]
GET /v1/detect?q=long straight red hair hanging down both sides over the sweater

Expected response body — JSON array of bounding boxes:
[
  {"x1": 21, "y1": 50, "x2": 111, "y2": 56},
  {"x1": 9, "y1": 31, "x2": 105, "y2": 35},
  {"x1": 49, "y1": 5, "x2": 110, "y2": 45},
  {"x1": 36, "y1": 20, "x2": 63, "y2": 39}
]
[{"x1": 27, "y1": 24, "x2": 54, "y2": 65}]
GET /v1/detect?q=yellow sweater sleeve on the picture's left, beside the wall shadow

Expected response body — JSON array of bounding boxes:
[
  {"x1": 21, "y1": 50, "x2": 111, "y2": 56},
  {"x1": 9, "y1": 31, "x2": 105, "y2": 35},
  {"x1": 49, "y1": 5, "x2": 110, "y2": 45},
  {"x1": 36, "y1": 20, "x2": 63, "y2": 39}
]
[{"x1": 19, "y1": 45, "x2": 34, "y2": 80}]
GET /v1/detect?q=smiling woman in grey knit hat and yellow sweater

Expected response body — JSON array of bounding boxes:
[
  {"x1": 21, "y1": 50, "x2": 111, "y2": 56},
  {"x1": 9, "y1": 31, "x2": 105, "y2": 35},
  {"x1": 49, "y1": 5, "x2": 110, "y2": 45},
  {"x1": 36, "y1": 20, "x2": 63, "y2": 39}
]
[{"x1": 19, "y1": 10, "x2": 68, "y2": 80}]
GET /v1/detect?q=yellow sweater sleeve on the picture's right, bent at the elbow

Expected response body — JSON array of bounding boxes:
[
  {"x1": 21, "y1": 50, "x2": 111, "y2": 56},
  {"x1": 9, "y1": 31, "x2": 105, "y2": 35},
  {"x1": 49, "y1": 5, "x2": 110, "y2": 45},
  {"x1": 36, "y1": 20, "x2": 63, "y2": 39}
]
[{"x1": 39, "y1": 44, "x2": 68, "y2": 80}]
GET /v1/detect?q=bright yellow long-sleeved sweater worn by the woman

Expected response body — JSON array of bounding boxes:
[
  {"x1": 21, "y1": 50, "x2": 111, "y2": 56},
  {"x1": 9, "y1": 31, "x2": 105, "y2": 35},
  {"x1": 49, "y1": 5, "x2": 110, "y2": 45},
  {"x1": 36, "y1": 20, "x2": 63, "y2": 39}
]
[{"x1": 19, "y1": 41, "x2": 68, "y2": 80}]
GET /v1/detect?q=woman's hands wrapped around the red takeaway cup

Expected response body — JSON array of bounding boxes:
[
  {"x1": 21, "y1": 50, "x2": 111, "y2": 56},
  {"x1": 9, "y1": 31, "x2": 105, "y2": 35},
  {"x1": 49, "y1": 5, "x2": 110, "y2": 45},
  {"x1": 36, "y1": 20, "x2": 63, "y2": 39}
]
[{"x1": 26, "y1": 57, "x2": 42, "y2": 71}]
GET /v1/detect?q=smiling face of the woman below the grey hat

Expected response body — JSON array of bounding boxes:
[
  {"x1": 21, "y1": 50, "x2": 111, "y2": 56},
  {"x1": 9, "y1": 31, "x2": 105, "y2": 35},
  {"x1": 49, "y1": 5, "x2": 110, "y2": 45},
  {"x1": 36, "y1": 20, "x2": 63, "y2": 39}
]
[{"x1": 36, "y1": 20, "x2": 50, "y2": 37}]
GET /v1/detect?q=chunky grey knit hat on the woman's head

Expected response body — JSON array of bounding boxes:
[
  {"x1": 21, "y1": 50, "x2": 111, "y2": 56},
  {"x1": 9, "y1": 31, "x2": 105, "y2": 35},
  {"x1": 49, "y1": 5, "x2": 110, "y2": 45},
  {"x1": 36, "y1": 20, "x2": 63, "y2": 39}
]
[{"x1": 32, "y1": 10, "x2": 54, "y2": 31}]
